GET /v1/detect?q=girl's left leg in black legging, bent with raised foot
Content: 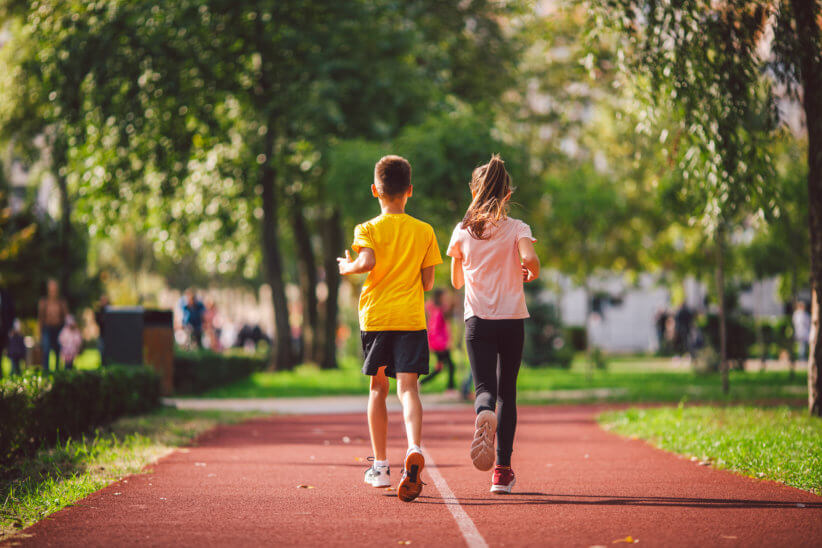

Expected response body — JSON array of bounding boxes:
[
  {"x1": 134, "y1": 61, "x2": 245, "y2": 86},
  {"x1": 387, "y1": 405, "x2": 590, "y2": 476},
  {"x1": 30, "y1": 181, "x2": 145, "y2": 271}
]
[{"x1": 465, "y1": 317, "x2": 498, "y2": 413}]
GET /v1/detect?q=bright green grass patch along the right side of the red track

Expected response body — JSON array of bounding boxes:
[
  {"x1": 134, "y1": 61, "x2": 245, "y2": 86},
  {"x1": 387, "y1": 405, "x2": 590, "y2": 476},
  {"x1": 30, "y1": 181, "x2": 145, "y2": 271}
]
[{"x1": 599, "y1": 405, "x2": 822, "y2": 494}]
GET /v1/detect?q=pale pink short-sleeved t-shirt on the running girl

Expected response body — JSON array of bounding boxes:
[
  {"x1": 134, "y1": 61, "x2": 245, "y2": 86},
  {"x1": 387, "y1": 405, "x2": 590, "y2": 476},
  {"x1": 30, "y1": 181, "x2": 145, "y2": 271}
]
[{"x1": 447, "y1": 217, "x2": 536, "y2": 320}]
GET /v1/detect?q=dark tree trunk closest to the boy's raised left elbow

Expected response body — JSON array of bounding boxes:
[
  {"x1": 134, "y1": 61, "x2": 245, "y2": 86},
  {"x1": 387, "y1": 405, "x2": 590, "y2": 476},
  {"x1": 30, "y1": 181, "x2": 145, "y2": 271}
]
[{"x1": 319, "y1": 208, "x2": 345, "y2": 369}]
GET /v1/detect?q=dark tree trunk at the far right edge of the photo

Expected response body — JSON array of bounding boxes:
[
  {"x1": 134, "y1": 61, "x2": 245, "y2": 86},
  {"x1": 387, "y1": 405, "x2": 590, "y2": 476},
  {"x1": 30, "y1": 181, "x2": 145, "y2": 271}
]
[{"x1": 792, "y1": 0, "x2": 822, "y2": 417}]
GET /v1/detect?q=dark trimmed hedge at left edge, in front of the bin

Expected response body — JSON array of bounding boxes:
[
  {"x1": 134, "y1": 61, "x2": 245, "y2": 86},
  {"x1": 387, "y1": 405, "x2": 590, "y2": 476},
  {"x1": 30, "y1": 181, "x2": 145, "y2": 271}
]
[{"x1": 0, "y1": 366, "x2": 160, "y2": 466}]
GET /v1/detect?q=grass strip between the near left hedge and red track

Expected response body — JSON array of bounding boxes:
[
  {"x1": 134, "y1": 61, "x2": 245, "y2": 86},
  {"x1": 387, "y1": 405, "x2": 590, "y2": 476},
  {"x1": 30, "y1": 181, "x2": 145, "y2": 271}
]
[{"x1": 0, "y1": 408, "x2": 264, "y2": 542}]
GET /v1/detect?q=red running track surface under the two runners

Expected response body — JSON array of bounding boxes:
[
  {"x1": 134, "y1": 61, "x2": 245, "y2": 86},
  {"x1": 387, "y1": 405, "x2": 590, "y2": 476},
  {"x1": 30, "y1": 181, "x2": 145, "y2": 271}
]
[{"x1": 11, "y1": 406, "x2": 822, "y2": 547}]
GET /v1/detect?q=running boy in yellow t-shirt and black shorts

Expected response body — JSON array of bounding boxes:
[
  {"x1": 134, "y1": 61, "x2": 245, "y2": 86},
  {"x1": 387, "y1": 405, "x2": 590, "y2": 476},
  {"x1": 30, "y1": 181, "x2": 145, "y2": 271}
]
[{"x1": 337, "y1": 156, "x2": 442, "y2": 502}]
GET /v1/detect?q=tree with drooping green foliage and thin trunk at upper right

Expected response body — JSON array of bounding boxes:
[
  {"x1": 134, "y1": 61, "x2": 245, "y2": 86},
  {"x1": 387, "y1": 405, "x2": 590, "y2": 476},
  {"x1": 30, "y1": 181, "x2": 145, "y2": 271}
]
[{"x1": 594, "y1": 0, "x2": 788, "y2": 392}]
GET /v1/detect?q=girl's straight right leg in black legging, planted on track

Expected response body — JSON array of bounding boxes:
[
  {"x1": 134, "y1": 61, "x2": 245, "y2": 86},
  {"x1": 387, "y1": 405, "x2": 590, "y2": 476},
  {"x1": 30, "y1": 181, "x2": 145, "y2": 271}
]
[{"x1": 497, "y1": 320, "x2": 525, "y2": 466}]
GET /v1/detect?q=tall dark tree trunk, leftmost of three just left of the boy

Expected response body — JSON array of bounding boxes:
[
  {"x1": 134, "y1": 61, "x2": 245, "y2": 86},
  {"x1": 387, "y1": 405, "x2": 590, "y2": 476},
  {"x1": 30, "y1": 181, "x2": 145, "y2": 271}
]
[{"x1": 260, "y1": 133, "x2": 294, "y2": 369}]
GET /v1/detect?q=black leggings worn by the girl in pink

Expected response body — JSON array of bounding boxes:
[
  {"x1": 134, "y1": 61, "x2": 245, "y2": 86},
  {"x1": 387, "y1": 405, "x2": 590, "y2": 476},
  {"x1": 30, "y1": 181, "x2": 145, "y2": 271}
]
[{"x1": 465, "y1": 316, "x2": 525, "y2": 466}]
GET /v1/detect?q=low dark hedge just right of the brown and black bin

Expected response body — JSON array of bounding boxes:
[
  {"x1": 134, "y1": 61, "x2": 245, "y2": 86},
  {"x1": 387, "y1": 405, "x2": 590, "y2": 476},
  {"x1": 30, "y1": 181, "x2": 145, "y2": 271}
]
[{"x1": 174, "y1": 350, "x2": 268, "y2": 394}]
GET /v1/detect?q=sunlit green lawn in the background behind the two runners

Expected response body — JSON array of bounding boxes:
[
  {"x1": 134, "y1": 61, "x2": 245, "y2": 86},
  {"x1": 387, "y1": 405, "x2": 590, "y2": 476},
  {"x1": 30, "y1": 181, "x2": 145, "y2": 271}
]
[{"x1": 195, "y1": 352, "x2": 806, "y2": 403}]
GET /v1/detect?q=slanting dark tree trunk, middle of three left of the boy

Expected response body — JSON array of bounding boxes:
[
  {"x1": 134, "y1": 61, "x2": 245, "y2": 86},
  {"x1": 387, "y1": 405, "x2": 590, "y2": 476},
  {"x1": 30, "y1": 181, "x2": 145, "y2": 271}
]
[{"x1": 291, "y1": 194, "x2": 320, "y2": 362}]
